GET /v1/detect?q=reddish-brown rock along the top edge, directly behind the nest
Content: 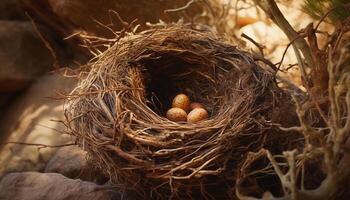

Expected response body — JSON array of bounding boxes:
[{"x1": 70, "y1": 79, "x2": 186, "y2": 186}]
[{"x1": 22, "y1": 0, "x2": 202, "y2": 37}]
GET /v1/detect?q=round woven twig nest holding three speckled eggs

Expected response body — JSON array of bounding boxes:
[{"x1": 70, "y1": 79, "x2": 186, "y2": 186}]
[{"x1": 65, "y1": 25, "x2": 296, "y2": 199}]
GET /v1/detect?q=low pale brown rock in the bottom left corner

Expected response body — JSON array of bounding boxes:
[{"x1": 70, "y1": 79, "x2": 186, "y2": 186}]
[{"x1": 0, "y1": 172, "x2": 125, "y2": 200}]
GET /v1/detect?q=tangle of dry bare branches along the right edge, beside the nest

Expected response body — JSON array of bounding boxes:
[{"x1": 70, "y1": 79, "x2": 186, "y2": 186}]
[{"x1": 236, "y1": 18, "x2": 350, "y2": 200}]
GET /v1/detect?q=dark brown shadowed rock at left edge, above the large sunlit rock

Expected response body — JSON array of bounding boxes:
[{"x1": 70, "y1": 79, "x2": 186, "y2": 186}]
[{"x1": 0, "y1": 20, "x2": 52, "y2": 92}]
